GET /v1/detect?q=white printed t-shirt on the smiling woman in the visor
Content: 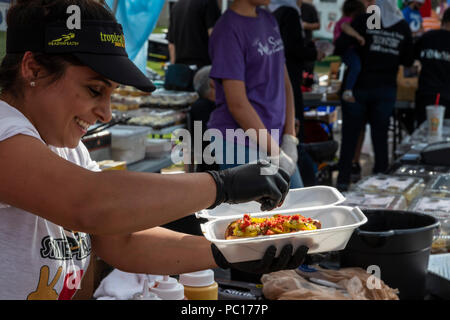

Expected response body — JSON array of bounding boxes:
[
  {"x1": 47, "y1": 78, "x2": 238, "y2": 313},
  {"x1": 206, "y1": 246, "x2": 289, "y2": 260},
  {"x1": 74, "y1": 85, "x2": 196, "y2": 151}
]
[{"x1": 0, "y1": 101, "x2": 100, "y2": 300}]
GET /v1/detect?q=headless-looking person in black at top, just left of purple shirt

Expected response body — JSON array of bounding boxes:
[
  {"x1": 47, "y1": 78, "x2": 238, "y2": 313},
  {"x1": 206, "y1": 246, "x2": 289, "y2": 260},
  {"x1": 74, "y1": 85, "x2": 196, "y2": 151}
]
[{"x1": 167, "y1": 0, "x2": 220, "y2": 69}]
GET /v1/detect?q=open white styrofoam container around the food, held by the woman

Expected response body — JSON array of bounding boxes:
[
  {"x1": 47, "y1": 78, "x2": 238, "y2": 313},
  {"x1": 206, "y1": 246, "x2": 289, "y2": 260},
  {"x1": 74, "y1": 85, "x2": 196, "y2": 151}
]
[{"x1": 196, "y1": 186, "x2": 367, "y2": 263}]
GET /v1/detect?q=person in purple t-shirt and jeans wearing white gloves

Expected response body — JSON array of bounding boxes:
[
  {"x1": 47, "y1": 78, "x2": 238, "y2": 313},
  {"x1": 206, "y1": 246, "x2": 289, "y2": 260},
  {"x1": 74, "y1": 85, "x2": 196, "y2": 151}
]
[{"x1": 208, "y1": 0, "x2": 303, "y2": 188}]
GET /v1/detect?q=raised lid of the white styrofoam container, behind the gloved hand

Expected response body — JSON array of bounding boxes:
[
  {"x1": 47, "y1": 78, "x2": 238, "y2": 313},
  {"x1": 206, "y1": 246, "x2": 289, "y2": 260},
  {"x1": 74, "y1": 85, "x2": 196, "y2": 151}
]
[{"x1": 196, "y1": 186, "x2": 345, "y2": 220}]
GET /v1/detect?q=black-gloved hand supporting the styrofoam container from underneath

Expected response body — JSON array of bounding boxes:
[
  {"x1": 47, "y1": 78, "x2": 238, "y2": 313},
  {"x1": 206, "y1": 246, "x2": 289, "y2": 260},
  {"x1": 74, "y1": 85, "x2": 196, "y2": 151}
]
[{"x1": 211, "y1": 243, "x2": 308, "y2": 274}]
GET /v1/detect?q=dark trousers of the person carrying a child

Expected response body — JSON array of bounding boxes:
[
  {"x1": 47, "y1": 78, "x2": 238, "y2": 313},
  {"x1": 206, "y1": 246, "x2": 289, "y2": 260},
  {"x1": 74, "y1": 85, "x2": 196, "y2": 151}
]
[{"x1": 337, "y1": 86, "x2": 397, "y2": 185}]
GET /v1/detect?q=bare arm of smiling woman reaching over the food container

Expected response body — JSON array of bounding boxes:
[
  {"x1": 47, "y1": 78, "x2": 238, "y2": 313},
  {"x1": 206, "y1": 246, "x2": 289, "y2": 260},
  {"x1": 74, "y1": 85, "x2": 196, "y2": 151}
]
[{"x1": 0, "y1": 135, "x2": 216, "y2": 234}]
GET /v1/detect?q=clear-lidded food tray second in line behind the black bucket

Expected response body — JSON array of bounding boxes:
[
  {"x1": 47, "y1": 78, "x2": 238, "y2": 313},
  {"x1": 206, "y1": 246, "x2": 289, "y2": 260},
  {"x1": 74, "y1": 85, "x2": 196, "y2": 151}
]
[{"x1": 352, "y1": 174, "x2": 425, "y2": 203}]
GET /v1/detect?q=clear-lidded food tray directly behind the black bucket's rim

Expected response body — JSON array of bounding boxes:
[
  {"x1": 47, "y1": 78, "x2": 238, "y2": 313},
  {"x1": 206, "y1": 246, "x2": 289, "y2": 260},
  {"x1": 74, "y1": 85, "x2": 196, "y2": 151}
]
[{"x1": 342, "y1": 192, "x2": 408, "y2": 210}]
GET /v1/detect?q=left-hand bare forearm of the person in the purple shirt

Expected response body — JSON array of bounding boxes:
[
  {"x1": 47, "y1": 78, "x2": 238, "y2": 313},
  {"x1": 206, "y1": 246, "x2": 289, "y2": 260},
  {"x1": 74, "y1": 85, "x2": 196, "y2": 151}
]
[{"x1": 222, "y1": 79, "x2": 279, "y2": 155}]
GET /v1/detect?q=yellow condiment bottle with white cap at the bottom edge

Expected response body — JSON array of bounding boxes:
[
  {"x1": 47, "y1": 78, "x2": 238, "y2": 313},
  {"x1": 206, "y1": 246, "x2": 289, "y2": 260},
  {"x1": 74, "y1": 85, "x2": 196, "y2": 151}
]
[{"x1": 180, "y1": 269, "x2": 219, "y2": 300}]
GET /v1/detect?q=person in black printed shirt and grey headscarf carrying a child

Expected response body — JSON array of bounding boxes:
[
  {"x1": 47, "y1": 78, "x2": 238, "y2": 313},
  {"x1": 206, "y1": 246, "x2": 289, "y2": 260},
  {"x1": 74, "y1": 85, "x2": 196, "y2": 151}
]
[{"x1": 336, "y1": 0, "x2": 414, "y2": 190}]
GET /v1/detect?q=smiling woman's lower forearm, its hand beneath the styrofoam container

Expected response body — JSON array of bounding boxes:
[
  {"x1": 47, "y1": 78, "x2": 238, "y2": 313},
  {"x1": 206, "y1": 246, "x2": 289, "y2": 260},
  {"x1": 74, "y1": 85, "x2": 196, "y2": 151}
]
[{"x1": 91, "y1": 227, "x2": 217, "y2": 275}]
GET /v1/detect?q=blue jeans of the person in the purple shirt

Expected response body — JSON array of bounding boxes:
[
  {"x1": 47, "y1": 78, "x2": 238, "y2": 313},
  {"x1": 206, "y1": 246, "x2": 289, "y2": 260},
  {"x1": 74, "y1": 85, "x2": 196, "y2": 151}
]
[{"x1": 216, "y1": 140, "x2": 303, "y2": 189}]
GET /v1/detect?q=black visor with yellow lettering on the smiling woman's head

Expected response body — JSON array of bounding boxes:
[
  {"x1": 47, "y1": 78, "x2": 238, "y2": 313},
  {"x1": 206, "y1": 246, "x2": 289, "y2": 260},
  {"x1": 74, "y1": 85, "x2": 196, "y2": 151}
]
[{"x1": 6, "y1": 20, "x2": 155, "y2": 92}]
